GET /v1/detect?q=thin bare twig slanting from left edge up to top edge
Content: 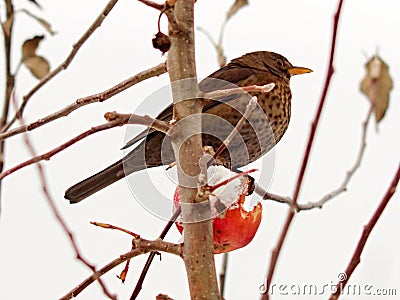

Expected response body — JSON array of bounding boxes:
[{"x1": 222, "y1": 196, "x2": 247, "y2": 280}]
[{"x1": 1, "y1": 0, "x2": 118, "y2": 132}]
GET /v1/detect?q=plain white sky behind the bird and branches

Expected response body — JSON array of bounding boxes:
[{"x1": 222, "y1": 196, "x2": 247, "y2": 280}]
[{"x1": 0, "y1": 0, "x2": 400, "y2": 300}]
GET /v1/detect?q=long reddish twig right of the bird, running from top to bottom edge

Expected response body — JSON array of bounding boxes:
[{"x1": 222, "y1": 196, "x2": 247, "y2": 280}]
[{"x1": 261, "y1": 0, "x2": 344, "y2": 299}]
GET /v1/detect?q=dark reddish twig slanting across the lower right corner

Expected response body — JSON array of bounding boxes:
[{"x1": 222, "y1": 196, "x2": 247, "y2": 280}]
[{"x1": 329, "y1": 165, "x2": 400, "y2": 300}]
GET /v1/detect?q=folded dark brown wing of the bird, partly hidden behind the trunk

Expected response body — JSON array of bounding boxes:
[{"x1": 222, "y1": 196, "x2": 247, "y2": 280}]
[{"x1": 122, "y1": 64, "x2": 257, "y2": 149}]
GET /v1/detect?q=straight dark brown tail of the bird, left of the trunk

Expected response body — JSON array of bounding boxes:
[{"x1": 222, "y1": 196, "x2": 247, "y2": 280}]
[{"x1": 64, "y1": 159, "x2": 125, "y2": 203}]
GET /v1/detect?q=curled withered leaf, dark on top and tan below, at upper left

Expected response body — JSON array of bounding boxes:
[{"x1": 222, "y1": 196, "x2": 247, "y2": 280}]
[{"x1": 22, "y1": 35, "x2": 50, "y2": 79}]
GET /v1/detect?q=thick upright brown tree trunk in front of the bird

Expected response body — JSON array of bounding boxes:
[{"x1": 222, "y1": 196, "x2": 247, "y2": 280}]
[{"x1": 168, "y1": 0, "x2": 220, "y2": 299}]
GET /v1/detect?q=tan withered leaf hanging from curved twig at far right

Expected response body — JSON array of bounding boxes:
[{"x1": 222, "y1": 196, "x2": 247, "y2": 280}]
[{"x1": 360, "y1": 55, "x2": 393, "y2": 123}]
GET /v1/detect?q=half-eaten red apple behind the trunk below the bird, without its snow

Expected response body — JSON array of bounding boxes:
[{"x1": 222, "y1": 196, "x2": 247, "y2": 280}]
[{"x1": 174, "y1": 182, "x2": 262, "y2": 254}]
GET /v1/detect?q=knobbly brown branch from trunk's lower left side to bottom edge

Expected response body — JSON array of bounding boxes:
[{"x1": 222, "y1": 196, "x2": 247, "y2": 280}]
[{"x1": 60, "y1": 238, "x2": 182, "y2": 300}]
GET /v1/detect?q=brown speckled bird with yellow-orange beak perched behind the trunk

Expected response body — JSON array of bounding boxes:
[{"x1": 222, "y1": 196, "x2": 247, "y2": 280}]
[{"x1": 65, "y1": 51, "x2": 312, "y2": 203}]
